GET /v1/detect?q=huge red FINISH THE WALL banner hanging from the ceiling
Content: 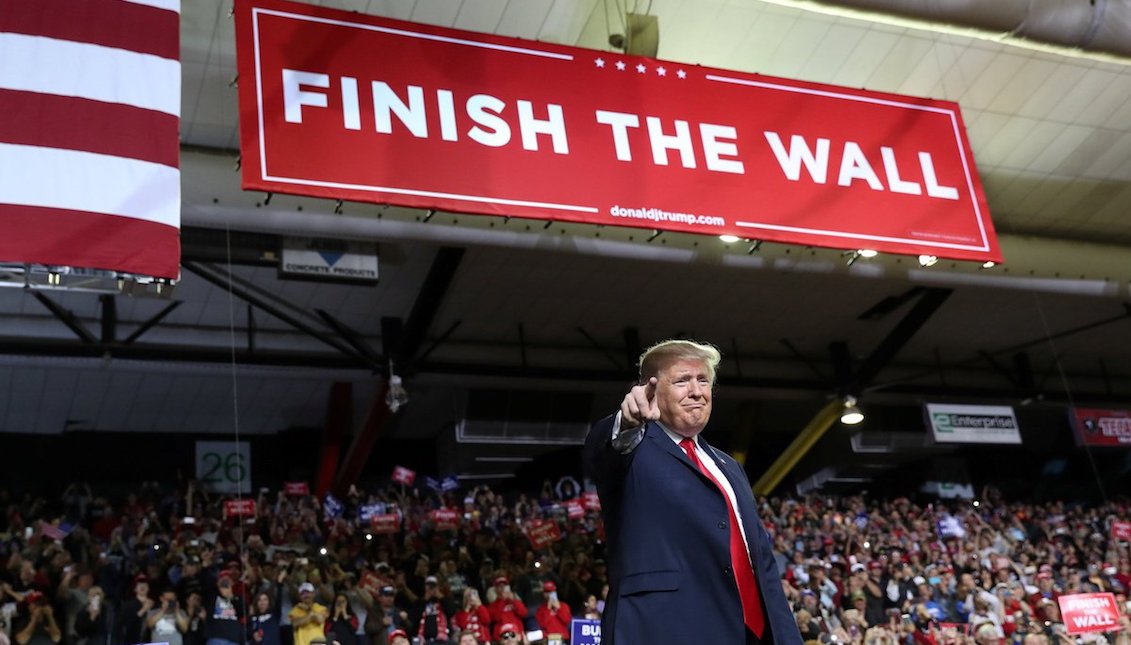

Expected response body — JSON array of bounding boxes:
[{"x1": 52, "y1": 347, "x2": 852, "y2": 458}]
[{"x1": 229, "y1": 0, "x2": 1001, "y2": 261}]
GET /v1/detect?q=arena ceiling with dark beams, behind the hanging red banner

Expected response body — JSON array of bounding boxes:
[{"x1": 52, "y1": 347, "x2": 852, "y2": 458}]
[{"x1": 0, "y1": 0, "x2": 1131, "y2": 491}]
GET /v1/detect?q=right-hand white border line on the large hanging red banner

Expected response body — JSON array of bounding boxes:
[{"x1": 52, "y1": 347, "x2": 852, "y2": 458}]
[{"x1": 705, "y1": 74, "x2": 990, "y2": 251}]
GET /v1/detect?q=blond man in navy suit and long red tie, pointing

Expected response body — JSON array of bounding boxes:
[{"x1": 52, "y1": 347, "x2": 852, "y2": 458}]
[{"x1": 585, "y1": 341, "x2": 802, "y2": 645}]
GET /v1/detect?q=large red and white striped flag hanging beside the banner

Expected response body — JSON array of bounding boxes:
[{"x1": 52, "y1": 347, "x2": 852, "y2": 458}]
[{"x1": 0, "y1": 0, "x2": 181, "y2": 278}]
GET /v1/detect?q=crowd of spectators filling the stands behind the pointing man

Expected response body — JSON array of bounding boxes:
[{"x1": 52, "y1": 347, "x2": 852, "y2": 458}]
[{"x1": 0, "y1": 482, "x2": 1131, "y2": 645}]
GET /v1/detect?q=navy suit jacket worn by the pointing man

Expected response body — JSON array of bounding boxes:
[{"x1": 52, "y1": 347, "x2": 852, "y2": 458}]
[{"x1": 585, "y1": 415, "x2": 802, "y2": 645}]
